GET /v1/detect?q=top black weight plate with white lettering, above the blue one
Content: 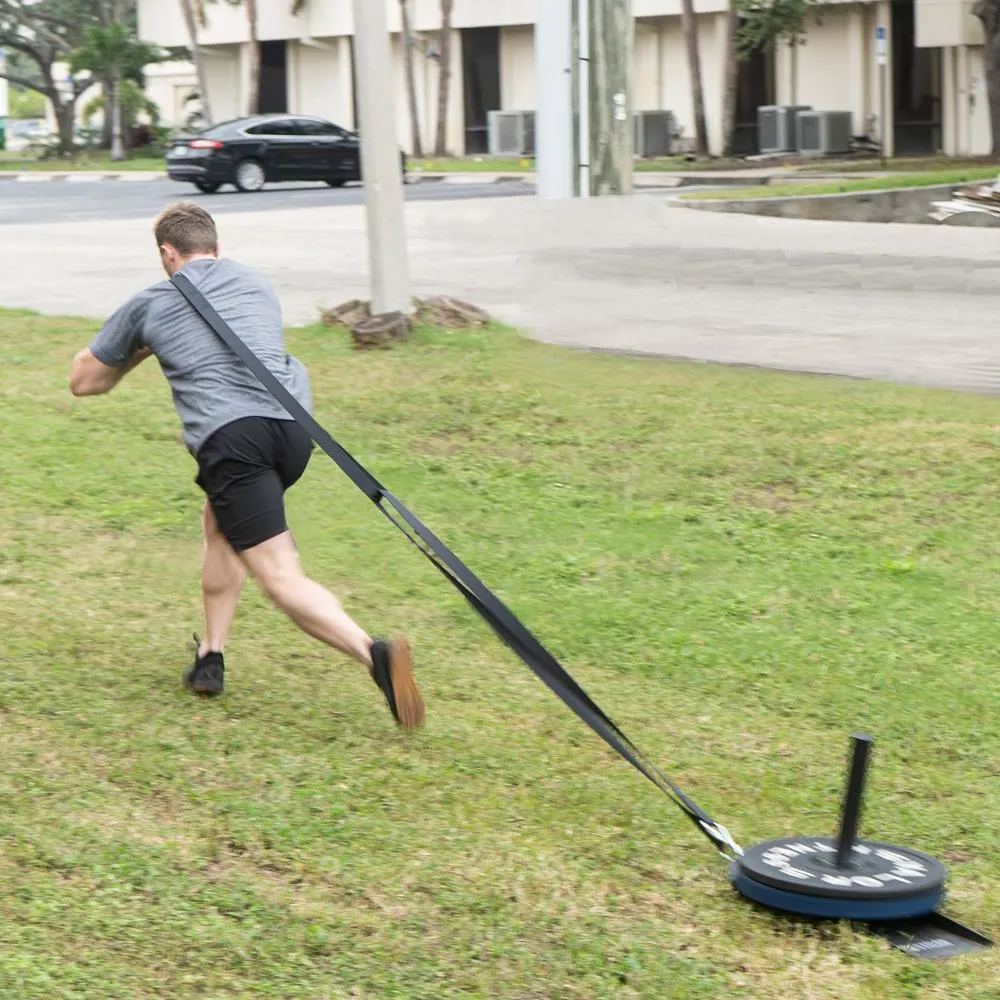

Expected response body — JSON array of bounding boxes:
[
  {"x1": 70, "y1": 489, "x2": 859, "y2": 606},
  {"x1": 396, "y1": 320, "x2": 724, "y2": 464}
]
[{"x1": 736, "y1": 837, "x2": 945, "y2": 902}]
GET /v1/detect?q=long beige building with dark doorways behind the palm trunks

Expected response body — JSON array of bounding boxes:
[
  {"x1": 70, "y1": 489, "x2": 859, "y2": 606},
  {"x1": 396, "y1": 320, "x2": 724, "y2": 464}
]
[{"x1": 139, "y1": 0, "x2": 991, "y2": 155}]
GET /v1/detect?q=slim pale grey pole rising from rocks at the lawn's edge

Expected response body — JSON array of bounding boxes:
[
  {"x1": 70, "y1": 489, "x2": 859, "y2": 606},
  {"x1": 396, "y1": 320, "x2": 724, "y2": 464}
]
[{"x1": 354, "y1": 0, "x2": 413, "y2": 316}]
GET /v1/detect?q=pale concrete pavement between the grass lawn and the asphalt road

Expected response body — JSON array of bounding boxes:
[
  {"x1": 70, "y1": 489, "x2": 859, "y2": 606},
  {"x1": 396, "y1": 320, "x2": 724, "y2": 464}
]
[{"x1": 0, "y1": 193, "x2": 1000, "y2": 392}]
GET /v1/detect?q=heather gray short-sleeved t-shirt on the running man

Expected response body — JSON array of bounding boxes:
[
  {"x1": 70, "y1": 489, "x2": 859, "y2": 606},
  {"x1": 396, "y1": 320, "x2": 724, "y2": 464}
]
[{"x1": 90, "y1": 259, "x2": 312, "y2": 454}]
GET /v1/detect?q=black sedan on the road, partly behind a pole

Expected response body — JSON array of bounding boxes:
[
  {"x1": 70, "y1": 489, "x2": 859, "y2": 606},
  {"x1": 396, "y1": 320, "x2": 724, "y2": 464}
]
[{"x1": 167, "y1": 114, "x2": 406, "y2": 194}]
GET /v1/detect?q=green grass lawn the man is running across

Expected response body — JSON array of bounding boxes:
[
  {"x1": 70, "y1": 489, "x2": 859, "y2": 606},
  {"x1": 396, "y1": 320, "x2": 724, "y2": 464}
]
[{"x1": 0, "y1": 313, "x2": 1000, "y2": 1000}]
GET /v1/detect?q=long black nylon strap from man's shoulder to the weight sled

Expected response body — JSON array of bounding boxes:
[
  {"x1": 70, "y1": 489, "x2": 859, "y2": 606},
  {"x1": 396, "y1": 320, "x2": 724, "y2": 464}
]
[{"x1": 172, "y1": 274, "x2": 739, "y2": 852}]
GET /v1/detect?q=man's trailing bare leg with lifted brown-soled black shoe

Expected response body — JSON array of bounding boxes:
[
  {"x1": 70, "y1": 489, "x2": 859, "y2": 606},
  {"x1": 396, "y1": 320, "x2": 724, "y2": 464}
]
[{"x1": 240, "y1": 531, "x2": 424, "y2": 728}]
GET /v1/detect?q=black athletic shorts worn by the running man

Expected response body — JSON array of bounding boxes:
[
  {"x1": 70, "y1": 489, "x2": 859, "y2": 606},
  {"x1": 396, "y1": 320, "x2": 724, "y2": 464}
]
[{"x1": 195, "y1": 417, "x2": 312, "y2": 552}]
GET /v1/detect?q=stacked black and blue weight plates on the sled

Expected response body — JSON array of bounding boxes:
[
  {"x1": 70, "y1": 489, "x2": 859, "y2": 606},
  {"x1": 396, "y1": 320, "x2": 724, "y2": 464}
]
[{"x1": 732, "y1": 837, "x2": 945, "y2": 919}]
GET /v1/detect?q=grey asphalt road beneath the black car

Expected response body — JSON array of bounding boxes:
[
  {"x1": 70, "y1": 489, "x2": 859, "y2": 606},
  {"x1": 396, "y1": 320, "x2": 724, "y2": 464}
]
[{"x1": 0, "y1": 177, "x2": 531, "y2": 225}]
